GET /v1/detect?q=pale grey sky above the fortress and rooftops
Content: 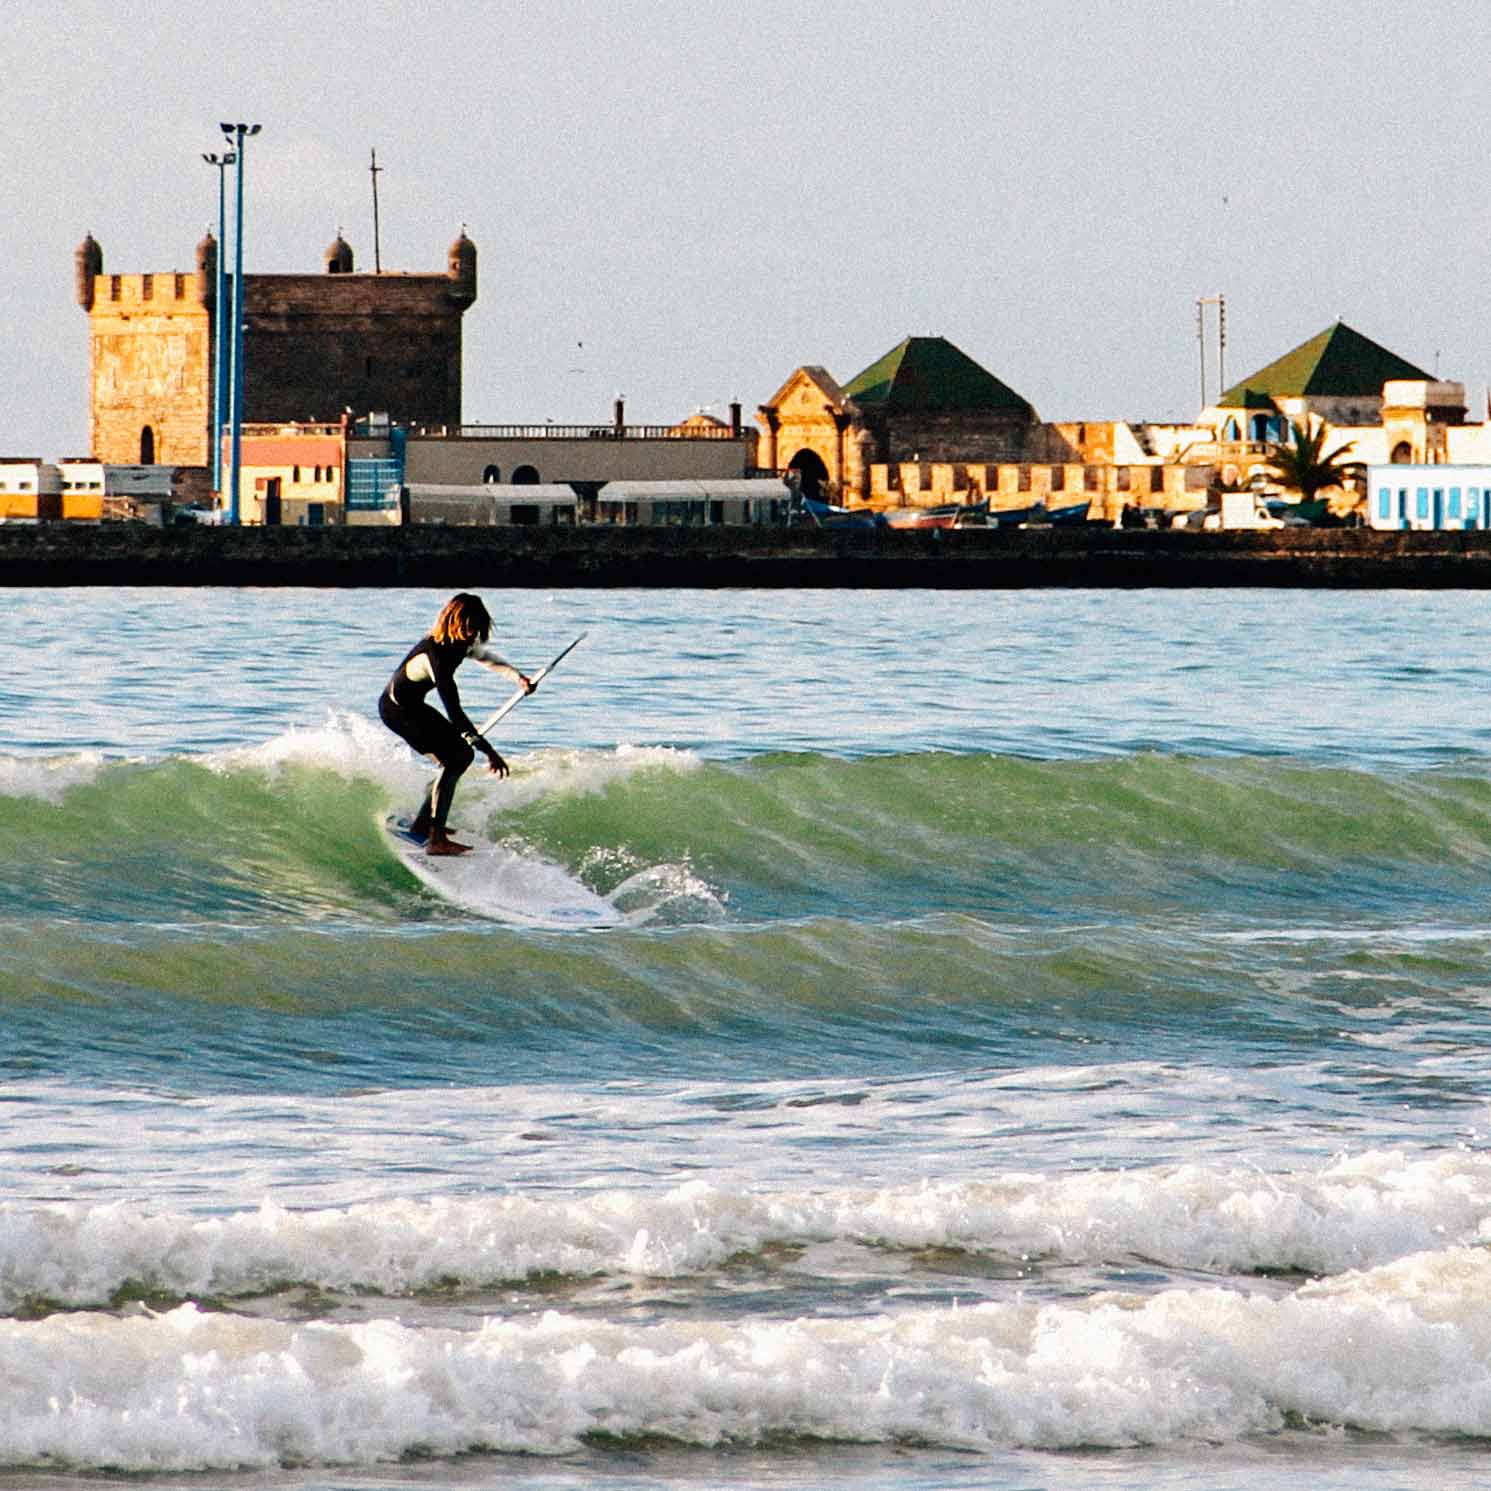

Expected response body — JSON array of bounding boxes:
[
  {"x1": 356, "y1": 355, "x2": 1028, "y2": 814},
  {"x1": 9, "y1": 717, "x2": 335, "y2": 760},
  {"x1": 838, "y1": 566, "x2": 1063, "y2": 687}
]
[{"x1": 0, "y1": 0, "x2": 1491, "y2": 459}]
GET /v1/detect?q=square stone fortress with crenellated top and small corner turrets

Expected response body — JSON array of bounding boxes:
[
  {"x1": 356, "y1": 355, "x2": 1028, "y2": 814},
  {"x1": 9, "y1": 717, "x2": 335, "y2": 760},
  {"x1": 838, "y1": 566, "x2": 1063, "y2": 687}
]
[{"x1": 75, "y1": 230, "x2": 477, "y2": 467}]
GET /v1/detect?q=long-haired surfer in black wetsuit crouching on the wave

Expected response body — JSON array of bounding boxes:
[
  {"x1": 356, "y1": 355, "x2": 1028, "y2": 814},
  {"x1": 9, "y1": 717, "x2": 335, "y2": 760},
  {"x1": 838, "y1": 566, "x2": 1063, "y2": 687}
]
[{"x1": 377, "y1": 592, "x2": 538, "y2": 854}]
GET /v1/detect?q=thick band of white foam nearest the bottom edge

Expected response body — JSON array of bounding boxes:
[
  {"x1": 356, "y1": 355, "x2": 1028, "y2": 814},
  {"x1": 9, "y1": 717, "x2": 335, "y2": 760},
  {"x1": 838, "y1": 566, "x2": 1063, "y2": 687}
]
[{"x1": 0, "y1": 1249, "x2": 1491, "y2": 1472}]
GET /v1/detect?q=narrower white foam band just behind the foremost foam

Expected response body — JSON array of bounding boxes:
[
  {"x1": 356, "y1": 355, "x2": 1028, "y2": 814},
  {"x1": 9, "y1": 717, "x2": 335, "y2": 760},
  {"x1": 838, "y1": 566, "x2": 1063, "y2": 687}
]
[{"x1": 0, "y1": 1154, "x2": 1491, "y2": 1311}]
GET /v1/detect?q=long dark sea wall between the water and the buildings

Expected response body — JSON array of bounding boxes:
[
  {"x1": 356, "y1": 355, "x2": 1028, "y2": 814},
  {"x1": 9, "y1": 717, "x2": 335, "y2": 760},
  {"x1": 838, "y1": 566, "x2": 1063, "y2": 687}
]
[{"x1": 0, "y1": 523, "x2": 1491, "y2": 589}]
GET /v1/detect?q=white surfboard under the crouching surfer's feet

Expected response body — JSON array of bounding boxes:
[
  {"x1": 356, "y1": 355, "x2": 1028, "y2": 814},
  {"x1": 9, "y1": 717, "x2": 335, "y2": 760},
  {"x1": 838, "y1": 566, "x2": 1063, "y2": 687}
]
[{"x1": 383, "y1": 816, "x2": 625, "y2": 932}]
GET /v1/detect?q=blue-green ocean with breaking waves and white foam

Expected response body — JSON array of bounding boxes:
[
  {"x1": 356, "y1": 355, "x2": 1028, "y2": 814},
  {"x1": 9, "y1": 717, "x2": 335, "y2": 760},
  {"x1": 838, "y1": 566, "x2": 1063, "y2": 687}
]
[{"x1": 0, "y1": 589, "x2": 1491, "y2": 1491}]
